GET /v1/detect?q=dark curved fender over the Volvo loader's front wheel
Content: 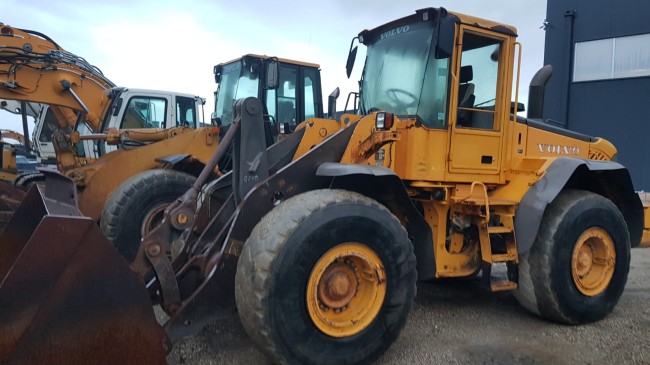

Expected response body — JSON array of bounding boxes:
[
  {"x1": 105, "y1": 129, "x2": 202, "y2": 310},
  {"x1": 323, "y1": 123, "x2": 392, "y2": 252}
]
[{"x1": 316, "y1": 162, "x2": 436, "y2": 280}]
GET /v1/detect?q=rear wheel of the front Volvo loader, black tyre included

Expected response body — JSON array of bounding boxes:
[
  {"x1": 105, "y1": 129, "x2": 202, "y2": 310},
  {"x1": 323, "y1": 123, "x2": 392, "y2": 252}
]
[{"x1": 515, "y1": 190, "x2": 630, "y2": 324}]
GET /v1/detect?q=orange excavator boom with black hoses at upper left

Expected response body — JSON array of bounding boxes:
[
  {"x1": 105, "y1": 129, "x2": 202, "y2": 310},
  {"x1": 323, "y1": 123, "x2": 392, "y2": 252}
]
[{"x1": 0, "y1": 23, "x2": 115, "y2": 132}]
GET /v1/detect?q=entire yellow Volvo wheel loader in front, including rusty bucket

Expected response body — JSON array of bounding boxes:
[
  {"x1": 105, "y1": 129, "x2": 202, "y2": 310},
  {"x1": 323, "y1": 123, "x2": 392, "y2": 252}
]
[{"x1": 0, "y1": 8, "x2": 650, "y2": 364}]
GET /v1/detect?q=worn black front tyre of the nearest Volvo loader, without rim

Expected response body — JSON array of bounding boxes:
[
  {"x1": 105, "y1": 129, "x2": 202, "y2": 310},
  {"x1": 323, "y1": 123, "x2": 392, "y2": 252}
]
[{"x1": 235, "y1": 190, "x2": 417, "y2": 365}]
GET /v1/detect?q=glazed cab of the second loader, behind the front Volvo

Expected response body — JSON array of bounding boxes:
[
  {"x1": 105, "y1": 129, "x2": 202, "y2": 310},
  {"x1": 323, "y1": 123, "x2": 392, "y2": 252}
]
[{"x1": 212, "y1": 54, "x2": 323, "y2": 138}]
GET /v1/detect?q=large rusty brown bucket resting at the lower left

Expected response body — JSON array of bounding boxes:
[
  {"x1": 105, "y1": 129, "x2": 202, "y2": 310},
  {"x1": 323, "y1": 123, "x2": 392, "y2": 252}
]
[{"x1": 0, "y1": 173, "x2": 170, "y2": 364}]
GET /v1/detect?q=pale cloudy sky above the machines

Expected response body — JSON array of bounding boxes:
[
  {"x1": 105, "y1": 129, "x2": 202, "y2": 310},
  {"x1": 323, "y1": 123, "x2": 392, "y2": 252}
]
[{"x1": 0, "y1": 0, "x2": 546, "y2": 135}]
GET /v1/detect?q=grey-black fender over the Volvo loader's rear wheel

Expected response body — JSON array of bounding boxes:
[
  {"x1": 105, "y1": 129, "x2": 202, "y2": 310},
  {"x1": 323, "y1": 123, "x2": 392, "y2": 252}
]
[{"x1": 515, "y1": 157, "x2": 643, "y2": 254}]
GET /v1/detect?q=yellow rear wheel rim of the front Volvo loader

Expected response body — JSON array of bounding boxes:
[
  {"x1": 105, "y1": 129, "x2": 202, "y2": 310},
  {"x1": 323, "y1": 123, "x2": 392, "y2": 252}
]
[{"x1": 571, "y1": 227, "x2": 616, "y2": 297}]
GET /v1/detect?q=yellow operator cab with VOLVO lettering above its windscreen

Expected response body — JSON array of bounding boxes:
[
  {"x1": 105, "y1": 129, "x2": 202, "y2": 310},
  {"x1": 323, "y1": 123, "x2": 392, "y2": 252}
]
[{"x1": 351, "y1": 8, "x2": 516, "y2": 183}]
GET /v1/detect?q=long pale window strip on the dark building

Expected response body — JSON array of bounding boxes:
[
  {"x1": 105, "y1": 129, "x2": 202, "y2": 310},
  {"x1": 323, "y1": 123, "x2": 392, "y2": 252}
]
[{"x1": 573, "y1": 34, "x2": 650, "y2": 82}]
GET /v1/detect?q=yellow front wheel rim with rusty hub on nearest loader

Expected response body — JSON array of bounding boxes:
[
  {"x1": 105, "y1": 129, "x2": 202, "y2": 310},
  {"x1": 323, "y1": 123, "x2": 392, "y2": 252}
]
[{"x1": 307, "y1": 243, "x2": 386, "y2": 337}]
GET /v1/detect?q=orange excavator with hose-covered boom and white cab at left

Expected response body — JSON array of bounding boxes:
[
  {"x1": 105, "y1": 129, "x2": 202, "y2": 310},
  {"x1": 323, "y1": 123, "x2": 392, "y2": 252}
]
[{"x1": 0, "y1": 23, "x2": 204, "y2": 173}]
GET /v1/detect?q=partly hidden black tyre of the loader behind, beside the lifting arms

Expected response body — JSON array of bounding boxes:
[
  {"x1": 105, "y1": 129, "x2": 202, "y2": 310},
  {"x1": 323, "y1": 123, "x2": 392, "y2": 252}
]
[{"x1": 100, "y1": 169, "x2": 195, "y2": 262}]
